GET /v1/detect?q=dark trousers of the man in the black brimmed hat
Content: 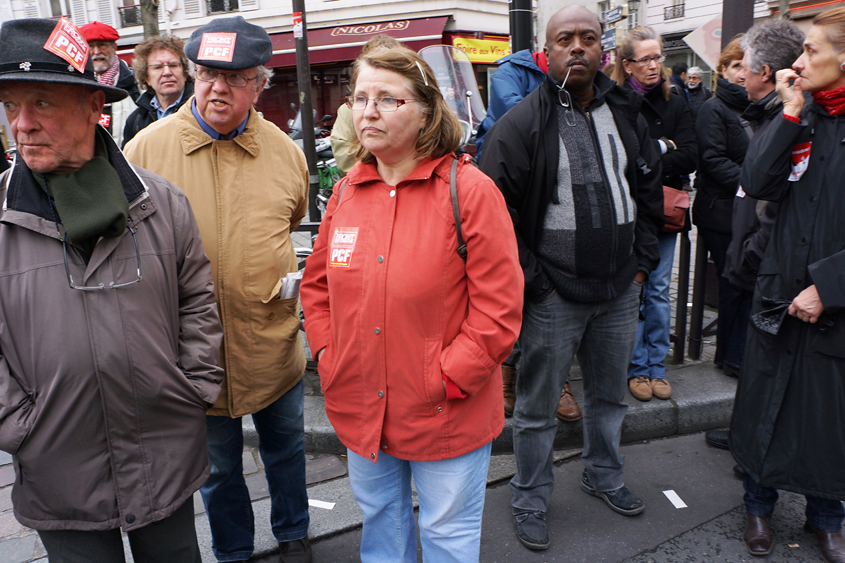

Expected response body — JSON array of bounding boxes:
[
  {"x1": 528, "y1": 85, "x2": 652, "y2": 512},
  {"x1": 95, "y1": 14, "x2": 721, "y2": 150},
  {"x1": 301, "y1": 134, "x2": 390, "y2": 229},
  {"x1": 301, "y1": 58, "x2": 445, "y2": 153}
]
[{"x1": 38, "y1": 497, "x2": 202, "y2": 563}]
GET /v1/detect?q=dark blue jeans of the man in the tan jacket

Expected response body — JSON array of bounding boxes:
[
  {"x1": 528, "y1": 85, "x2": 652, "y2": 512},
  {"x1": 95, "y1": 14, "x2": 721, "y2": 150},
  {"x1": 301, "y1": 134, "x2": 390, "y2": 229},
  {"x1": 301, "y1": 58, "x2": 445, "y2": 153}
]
[{"x1": 200, "y1": 381, "x2": 309, "y2": 561}]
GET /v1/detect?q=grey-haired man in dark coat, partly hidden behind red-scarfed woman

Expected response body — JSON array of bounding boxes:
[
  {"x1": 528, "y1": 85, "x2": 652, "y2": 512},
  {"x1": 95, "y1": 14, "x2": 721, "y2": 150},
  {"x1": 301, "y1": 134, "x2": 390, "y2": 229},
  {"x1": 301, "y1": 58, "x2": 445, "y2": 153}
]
[{"x1": 705, "y1": 18, "x2": 804, "y2": 456}]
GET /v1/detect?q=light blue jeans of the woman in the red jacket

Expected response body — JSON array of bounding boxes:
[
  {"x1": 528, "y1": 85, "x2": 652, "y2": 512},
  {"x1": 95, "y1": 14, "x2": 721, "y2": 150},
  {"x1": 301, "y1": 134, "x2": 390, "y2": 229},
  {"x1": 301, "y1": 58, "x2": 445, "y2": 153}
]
[{"x1": 348, "y1": 444, "x2": 491, "y2": 563}]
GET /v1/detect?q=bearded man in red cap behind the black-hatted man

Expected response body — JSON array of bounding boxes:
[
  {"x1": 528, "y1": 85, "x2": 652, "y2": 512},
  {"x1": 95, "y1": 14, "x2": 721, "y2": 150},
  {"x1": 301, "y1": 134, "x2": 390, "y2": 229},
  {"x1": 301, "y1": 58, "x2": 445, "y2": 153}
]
[{"x1": 79, "y1": 22, "x2": 141, "y2": 146}]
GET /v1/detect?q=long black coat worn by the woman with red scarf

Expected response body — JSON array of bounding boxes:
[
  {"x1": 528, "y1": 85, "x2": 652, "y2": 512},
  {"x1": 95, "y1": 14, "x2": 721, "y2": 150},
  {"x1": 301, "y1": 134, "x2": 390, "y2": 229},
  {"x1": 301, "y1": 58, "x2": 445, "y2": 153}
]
[{"x1": 730, "y1": 102, "x2": 845, "y2": 500}]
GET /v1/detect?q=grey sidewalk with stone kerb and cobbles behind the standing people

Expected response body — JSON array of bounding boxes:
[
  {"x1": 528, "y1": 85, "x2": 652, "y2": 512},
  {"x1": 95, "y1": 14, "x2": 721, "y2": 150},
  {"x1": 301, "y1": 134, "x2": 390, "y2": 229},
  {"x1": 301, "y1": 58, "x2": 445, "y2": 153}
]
[{"x1": 0, "y1": 349, "x2": 736, "y2": 563}]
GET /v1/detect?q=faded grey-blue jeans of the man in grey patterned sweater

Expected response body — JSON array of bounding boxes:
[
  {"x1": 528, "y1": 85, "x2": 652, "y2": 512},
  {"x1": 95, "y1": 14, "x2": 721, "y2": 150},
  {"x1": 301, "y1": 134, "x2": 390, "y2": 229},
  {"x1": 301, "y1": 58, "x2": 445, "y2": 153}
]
[{"x1": 510, "y1": 282, "x2": 642, "y2": 514}]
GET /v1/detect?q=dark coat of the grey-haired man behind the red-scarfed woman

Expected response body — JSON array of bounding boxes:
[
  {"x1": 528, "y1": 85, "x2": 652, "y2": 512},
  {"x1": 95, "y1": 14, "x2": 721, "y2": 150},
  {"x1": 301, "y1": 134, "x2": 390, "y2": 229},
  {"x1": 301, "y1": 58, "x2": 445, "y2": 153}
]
[{"x1": 722, "y1": 90, "x2": 783, "y2": 292}]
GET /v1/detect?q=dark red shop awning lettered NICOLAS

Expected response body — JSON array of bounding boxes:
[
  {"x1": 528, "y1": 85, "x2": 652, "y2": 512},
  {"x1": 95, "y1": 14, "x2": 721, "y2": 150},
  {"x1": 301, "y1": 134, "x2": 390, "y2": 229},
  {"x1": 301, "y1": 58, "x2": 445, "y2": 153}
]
[{"x1": 267, "y1": 16, "x2": 448, "y2": 68}]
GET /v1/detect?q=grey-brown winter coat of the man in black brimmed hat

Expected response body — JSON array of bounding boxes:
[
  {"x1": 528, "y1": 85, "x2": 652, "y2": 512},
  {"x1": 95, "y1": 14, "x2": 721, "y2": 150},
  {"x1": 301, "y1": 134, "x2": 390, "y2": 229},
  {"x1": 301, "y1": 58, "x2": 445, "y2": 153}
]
[{"x1": 0, "y1": 128, "x2": 223, "y2": 531}]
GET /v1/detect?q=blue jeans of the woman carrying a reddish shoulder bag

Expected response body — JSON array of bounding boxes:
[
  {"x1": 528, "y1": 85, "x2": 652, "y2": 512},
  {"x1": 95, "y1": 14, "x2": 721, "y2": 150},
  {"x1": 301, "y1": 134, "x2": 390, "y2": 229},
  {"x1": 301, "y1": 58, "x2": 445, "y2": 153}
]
[{"x1": 628, "y1": 233, "x2": 678, "y2": 379}]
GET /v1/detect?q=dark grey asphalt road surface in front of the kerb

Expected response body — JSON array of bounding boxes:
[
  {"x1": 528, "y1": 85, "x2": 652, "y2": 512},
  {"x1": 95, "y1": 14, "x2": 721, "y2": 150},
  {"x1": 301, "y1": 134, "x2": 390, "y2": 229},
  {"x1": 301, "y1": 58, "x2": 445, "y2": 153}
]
[{"x1": 282, "y1": 434, "x2": 836, "y2": 563}]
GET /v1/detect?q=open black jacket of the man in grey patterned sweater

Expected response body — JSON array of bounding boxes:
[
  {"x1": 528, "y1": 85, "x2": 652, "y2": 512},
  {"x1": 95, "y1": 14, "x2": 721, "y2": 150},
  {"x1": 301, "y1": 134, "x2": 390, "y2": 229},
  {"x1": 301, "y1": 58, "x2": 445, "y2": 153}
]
[{"x1": 479, "y1": 72, "x2": 663, "y2": 299}]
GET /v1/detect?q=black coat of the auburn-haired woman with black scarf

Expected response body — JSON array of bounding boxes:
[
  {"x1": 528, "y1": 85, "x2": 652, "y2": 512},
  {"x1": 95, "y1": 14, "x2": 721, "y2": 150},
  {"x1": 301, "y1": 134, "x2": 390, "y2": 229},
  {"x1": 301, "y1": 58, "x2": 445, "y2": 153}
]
[{"x1": 692, "y1": 78, "x2": 751, "y2": 234}]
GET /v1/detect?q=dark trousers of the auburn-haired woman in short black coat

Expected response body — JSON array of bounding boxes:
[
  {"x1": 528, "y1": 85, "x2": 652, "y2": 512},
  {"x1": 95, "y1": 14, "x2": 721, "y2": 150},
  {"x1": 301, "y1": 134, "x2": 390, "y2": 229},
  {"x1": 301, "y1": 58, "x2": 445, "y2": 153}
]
[{"x1": 698, "y1": 228, "x2": 753, "y2": 370}]
